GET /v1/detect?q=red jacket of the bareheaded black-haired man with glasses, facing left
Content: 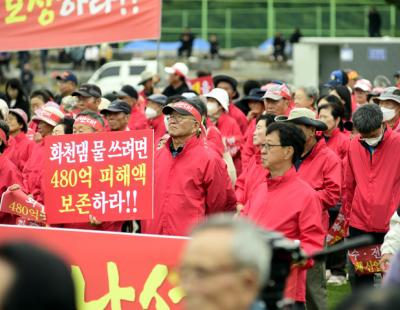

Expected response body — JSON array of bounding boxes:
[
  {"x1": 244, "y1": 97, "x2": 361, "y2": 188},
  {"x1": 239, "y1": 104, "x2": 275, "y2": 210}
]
[{"x1": 242, "y1": 168, "x2": 325, "y2": 302}]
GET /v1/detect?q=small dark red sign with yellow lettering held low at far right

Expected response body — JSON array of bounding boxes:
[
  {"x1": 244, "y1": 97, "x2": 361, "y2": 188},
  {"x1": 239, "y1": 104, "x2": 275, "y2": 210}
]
[{"x1": 348, "y1": 244, "x2": 382, "y2": 274}]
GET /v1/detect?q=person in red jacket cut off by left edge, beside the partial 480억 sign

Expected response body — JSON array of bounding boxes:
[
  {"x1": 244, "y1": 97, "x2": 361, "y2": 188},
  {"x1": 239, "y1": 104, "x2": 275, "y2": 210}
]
[{"x1": 0, "y1": 120, "x2": 22, "y2": 224}]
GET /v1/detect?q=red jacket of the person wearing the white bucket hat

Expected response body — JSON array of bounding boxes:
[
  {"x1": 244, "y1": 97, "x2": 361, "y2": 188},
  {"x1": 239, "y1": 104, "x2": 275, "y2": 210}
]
[{"x1": 208, "y1": 113, "x2": 243, "y2": 175}]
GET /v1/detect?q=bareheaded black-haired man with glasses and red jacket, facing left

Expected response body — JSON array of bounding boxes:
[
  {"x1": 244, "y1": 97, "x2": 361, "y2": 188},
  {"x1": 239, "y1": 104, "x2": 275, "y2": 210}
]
[{"x1": 242, "y1": 122, "x2": 325, "y2": 309}]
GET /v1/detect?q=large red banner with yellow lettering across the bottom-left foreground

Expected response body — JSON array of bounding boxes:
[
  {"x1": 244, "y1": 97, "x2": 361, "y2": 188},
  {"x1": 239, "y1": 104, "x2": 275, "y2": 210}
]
[{"x1": 0, "y1": 225, "x2": 186, "y2": 310}]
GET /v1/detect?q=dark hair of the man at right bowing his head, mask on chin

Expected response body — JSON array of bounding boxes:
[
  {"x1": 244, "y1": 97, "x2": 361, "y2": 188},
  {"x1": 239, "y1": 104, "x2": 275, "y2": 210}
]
[{"x1": 353, "y1": 103, "x2": 383, "y2": 134}]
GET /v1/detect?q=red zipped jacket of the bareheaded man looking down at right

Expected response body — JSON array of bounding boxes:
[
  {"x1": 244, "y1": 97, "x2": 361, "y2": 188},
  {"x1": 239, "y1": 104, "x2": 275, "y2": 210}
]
[{"x1": 343, "y1": 128, "x2": 400, "y2": 233}]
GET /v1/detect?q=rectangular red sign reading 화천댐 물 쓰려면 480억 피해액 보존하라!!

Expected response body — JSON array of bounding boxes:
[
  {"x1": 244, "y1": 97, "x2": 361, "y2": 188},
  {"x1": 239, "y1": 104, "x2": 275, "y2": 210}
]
[{"x1": 43, "y1": 130, "x2": 153, "y2": 224}]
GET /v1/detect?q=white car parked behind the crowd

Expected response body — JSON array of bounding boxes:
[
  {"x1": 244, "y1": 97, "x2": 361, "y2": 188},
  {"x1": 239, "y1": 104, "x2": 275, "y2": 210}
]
[{"x1": 88, "y1": 59, "x2": 157, "y2": 94}]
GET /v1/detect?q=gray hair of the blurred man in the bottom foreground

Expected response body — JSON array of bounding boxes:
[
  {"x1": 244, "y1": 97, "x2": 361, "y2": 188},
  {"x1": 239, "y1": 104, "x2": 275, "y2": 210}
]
[{"x1": 191, "y1": 214, "x2": 272, "y2": 286}]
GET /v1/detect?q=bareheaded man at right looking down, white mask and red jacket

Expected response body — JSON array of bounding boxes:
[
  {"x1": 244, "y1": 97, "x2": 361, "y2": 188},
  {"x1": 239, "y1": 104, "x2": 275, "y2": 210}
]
[{"x1": 343, "y1": 104, "x2": 400, "y2": 287}]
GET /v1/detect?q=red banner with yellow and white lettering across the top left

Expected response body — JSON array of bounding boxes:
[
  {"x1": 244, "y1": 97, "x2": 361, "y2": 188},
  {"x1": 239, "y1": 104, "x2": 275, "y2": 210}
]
[{"x1": 0, "y1": 0, "x2": 161, "y2": 51}]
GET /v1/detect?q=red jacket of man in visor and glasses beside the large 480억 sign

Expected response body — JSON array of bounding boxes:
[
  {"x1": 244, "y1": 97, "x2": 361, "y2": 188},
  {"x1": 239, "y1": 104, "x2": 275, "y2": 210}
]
[{"x1": 142, "y1": 136, "x2": 236, "y2": 236}]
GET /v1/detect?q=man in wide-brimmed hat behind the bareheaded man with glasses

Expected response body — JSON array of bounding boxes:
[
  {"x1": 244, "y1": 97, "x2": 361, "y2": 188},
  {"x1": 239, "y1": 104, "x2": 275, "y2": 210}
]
[{"x1": 277, "y1": 108, "x2": 342, "y2": 309}]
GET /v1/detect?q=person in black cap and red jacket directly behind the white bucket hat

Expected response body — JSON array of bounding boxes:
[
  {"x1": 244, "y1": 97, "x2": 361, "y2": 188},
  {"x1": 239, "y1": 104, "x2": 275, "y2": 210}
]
[{"x1": 213, "y1": 75, "x2": 247, "y2": 134}]
